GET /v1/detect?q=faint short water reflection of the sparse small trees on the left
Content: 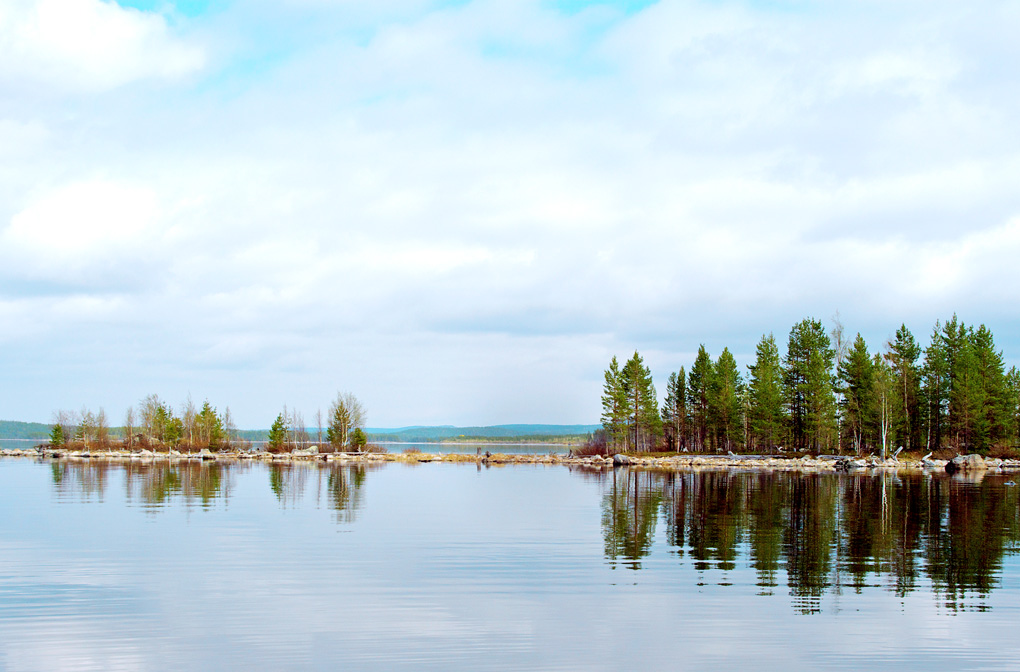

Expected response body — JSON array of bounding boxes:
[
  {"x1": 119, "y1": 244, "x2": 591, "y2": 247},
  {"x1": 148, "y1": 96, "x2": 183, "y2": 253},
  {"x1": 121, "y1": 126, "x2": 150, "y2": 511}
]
[{"x1": 50, "y1": 460, "x2": 373, "y2": 522}]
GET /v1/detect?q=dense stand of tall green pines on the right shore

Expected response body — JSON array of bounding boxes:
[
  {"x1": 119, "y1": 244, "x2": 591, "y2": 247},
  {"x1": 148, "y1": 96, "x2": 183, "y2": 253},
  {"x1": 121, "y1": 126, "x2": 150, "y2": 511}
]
[{"x1": 598, "y1": 315, "x2": 1020, "y2": 456}]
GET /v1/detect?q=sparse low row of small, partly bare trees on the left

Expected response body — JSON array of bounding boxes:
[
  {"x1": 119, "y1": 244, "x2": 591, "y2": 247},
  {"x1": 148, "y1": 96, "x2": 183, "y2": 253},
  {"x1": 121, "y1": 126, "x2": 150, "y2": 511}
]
[{"x1": 49, "y1": 393, "x2": 368, "y2": 452}]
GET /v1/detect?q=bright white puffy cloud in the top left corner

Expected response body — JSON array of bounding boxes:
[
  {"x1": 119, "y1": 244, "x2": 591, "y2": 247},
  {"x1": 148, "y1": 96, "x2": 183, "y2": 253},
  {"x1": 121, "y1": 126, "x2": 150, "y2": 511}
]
[{"x1": 0, "y1": 0, "x2": 205, "y2": 91}]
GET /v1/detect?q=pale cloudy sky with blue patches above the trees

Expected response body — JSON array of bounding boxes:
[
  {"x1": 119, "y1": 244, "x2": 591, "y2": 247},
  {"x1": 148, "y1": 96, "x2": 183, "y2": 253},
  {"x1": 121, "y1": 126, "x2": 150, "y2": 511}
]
[{"x1": 0, "y1": 0, "x2": 1020, "y2": 427}]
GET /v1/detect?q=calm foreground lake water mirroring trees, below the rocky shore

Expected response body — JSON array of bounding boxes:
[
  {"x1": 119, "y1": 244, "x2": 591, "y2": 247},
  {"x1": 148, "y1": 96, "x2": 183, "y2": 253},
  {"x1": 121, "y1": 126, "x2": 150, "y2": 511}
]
[{"x1": 0, "y1": 459, "x2": 1020, "y2": 670}]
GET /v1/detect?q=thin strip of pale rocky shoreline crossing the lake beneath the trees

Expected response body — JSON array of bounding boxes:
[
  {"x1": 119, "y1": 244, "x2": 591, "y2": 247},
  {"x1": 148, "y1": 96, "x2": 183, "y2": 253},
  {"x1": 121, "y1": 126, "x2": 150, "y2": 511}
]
[{"x1": 0, "y1": 448, "x2": 1020, "y2": 473}]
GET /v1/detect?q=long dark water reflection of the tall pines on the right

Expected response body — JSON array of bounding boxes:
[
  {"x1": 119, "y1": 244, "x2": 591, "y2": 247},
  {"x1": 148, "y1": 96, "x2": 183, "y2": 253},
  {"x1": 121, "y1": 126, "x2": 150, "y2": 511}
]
[{"x1": 602, "y1": 470, "x2": 1020, "y2": 611}]
